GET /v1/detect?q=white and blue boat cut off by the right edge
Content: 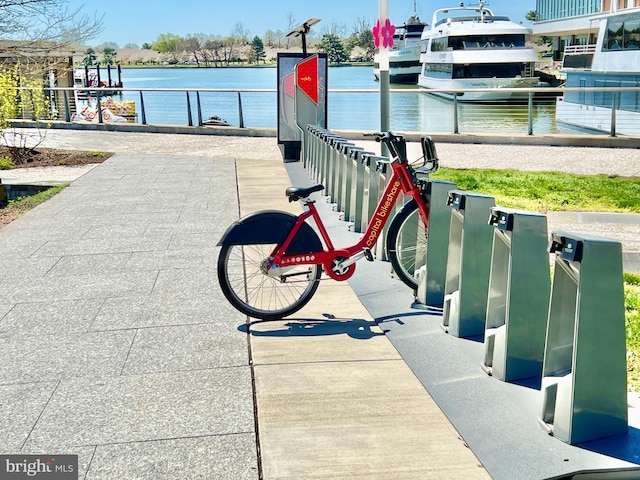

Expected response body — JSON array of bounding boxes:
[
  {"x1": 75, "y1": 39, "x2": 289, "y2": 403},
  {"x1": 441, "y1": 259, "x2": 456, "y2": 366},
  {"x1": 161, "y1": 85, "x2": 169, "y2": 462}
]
[{"x1": 556, "y1": 8, "x2": 640, "y2": 135}]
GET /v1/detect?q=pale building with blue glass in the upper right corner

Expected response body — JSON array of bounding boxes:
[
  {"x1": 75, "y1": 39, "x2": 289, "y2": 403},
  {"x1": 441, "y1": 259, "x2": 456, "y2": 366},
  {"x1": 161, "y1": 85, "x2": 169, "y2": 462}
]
[{"x1": 533, "y1": 0, "x2": 640, "y2": 61}]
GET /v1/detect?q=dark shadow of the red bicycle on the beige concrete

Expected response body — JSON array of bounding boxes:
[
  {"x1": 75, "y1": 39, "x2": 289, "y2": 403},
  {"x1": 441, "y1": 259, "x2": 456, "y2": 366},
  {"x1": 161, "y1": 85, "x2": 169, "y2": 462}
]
[{"x1": 238, "y1": 315, "x2": 384, "y2": 340}]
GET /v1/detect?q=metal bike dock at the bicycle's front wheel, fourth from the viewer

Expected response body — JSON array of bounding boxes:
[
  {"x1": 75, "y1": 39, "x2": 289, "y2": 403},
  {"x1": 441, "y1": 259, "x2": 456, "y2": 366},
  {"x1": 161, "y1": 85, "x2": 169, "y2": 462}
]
[{"x1": 416, "y1": 179, "x2": 456, "y2": 308}]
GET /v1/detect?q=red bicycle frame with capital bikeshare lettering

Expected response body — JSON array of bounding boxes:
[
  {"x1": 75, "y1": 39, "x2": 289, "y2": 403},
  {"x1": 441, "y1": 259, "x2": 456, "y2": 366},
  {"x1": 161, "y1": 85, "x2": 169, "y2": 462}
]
[{"x1": 270, "y1": 157, "x2": 429, "y2": 280}]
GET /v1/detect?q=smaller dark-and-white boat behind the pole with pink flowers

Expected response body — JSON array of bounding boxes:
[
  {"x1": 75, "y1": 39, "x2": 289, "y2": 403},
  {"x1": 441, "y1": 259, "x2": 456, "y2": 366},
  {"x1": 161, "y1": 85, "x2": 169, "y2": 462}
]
[{"x1": 373, "y1": 1, "x2": 427, "y2": 85}]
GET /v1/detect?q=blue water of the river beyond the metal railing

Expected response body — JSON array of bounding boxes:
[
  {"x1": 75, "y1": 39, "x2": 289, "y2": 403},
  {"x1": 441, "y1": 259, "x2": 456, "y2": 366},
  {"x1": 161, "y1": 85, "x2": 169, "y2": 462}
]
[{"x1": 117, "y1": 67, "x2": 557, "y2": 134}]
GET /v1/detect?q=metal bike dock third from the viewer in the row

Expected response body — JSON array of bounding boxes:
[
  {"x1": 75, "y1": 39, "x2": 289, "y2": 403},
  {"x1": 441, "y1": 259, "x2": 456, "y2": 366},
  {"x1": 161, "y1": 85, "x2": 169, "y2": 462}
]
[{"x1": 442, "y1": 190, "x2": 495, "y2": 337}]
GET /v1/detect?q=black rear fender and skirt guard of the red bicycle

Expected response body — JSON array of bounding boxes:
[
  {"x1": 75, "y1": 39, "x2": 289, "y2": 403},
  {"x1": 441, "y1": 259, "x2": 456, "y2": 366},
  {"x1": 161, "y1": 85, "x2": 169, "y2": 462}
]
[{"x1": 218, "y1": 210, "x2": 323, "y2": 255}]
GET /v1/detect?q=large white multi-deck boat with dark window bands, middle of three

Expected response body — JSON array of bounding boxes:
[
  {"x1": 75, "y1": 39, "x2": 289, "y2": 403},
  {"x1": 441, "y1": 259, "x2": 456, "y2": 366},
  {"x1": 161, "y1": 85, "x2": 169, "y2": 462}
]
[{"x1": 418, "y1": 1, "x2": 539, "y2": 102}]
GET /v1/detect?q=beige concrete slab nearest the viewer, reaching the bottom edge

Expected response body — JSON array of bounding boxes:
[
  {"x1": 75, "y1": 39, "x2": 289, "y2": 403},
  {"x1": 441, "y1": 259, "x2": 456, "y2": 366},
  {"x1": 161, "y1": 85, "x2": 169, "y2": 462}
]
[{"x1": 255, "y1": 362, "x2": 490, "y2": 479}]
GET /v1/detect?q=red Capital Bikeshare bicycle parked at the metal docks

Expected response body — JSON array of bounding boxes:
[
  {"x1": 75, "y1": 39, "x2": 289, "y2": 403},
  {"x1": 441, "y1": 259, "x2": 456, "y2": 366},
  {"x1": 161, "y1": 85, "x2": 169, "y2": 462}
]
[{"x1": 218, "y1": 132, "x2": 438, "y2": 320}]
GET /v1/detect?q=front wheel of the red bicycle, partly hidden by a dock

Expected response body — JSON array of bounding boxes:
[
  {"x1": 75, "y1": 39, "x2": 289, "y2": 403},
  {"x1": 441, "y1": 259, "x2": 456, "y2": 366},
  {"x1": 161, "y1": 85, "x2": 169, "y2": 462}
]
[{"x1": 386, "y1": 199, "x2": 429, "y2": 290}]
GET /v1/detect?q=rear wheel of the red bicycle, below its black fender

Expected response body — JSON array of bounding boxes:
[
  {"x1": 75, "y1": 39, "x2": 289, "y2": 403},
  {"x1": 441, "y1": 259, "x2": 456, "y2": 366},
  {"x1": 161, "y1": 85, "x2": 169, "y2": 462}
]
[{"x1": 218, "y1": 244, "x2": 322, "y2": 320}]
